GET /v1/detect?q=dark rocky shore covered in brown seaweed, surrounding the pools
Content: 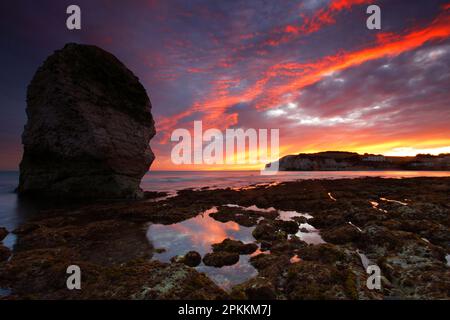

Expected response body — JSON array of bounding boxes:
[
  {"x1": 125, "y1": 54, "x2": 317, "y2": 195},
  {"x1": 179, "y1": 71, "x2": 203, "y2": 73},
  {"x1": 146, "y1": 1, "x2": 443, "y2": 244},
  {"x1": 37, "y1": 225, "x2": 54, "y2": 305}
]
[{"x1": 0, "y1": 178, "x2": 450, "y2": 299}]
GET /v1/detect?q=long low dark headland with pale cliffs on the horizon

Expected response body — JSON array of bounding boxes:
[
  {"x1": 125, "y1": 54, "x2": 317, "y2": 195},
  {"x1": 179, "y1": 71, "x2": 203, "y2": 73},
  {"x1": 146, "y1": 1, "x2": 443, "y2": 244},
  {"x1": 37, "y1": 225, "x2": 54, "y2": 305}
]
[{"x1": 267, "y1": 151, "x2": 450, "y2": 171}]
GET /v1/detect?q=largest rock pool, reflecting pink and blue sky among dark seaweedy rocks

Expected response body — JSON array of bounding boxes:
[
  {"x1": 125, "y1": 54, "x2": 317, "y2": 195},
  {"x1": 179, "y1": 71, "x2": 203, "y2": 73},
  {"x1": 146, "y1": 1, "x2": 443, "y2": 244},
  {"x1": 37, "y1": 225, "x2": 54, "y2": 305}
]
[{"x1": 147, "y1": 207, "x2": 260, "y2": 289}]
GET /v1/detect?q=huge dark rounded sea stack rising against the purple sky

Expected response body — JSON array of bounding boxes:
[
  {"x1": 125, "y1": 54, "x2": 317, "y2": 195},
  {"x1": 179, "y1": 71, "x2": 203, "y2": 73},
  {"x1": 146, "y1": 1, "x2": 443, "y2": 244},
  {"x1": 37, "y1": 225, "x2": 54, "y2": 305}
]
[{"x1": 18, "y1": 43, "x2": 155, "y2": 199}]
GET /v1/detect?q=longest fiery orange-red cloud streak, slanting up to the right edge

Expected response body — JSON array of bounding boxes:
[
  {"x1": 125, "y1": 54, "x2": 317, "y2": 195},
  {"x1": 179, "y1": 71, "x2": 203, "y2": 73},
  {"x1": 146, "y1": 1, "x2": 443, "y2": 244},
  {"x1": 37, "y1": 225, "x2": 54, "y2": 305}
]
[{"x1": 158, "y1": 8, "x2": 450, "y2": 141}]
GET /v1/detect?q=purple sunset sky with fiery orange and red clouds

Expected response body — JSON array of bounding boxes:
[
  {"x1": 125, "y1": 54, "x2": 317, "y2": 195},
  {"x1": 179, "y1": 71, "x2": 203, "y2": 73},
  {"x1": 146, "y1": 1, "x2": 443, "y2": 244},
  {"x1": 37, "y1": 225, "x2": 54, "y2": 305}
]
[{"x1": 0, "y1": 0, "x2": 450, "y2": 170}]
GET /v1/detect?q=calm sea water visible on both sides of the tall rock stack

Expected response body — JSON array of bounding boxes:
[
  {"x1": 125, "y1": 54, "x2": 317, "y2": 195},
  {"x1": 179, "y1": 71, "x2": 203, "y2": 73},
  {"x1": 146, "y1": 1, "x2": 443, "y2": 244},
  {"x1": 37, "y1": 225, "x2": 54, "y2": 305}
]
[{"x1": 0, "y1": 171, "x2": 450, "y2": 230}]
